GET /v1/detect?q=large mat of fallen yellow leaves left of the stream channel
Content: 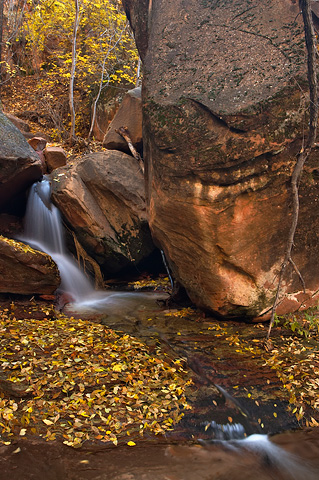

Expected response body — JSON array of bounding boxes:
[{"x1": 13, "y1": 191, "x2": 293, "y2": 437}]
[{"x1": 0, "y1": 307, "x2": 191, "y2": 447}]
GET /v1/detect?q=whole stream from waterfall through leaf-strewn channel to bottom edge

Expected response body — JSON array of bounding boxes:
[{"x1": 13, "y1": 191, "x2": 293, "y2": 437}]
[{"x1": 0, "y1": 178, "x2": 319, "y2": 480}]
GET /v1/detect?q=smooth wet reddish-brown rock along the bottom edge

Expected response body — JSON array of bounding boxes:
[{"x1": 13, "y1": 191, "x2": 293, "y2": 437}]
[{"x1": 0, "y1": 431, "x2": 319, "y2": 480}]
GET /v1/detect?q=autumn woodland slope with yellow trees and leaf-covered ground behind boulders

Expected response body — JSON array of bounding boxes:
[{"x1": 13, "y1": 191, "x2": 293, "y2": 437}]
[{"x1": 0, "y1": 0, "x2": 138, "y2": 144}]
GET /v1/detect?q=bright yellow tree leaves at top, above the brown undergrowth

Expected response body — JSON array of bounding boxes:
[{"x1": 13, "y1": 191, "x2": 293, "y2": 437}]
[{"x1": 26, "y1": 0, "x2": 138, "y2": 91}]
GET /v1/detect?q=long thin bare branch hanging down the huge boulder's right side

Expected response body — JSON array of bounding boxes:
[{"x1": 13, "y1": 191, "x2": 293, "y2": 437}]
[{"x1": 266, "y1": 0, "x2": 318, "y2": 349}]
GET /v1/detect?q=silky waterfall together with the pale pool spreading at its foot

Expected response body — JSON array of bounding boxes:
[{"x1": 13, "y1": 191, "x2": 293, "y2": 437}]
[{"x1": 19, "y1": 176, "x2": 169, "y2": 315}]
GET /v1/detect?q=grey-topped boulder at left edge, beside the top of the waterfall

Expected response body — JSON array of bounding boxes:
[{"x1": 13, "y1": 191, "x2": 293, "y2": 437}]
[{"x1": 0, "y1": 112, "x2": 42, "y2": 209}]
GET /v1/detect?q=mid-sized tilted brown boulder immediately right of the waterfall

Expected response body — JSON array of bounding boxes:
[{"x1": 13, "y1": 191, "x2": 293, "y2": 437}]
[{"x1": 52, "y1": 151, "x2": 154, "y2": 277}]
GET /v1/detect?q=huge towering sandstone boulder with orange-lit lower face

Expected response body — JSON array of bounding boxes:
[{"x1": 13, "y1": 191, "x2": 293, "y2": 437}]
[{"x1": 123, "y1": 0, "x2": 319, "y2": 317}]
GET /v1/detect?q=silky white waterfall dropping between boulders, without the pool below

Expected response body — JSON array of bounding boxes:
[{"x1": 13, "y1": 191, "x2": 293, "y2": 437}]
[{"x1": 20, "y1": 176, "x2": 95, "y2": 303}]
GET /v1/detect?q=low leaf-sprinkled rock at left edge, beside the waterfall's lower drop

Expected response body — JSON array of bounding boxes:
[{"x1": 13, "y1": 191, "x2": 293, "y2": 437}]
[{"x1": 0, "y1": 236, "x2": 60, "y2": 295}]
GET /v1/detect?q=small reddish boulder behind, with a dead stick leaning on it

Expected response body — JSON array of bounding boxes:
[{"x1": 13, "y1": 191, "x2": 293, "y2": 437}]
[{"x1": 103, "y1": 87, "x2": 143, "y2": 153}]
